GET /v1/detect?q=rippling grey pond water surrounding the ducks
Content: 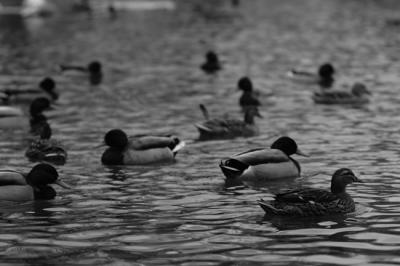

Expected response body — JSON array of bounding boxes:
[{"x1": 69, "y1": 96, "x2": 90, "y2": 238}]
[{"x1": 0, "y1": 0, "x2": 400, "y2": 265}]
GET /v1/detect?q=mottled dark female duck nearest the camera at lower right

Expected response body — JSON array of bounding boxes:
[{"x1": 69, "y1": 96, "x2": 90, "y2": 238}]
[{"x1": 258, "y1": 168, "x2": 362, "y2": 216}]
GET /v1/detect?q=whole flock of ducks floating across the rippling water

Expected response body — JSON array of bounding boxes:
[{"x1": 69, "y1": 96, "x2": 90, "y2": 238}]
[{"x1": 0, "y1": 51, "x2": 369, "y2": 216}]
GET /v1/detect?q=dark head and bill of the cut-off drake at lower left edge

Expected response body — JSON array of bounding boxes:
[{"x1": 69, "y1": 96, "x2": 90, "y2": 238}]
[{"x1": 25, "y1": 163, "x2": 71, "y2": 200}]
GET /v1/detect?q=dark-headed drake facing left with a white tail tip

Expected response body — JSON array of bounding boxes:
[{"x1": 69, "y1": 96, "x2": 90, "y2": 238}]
[{"x1": 101, "y1": 129, "x2": 185, "y2": 165}]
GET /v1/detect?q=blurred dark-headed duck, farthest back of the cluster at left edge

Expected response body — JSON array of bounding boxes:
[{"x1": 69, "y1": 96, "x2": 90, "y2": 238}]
[{"x1": 3, "y1": 77, "x2": 59, "y2": 103}]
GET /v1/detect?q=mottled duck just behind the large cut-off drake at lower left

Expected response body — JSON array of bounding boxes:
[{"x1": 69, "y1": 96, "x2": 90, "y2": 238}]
[{"x1": 25, "y1": 122, "x2": 67, "y2": 165}]
